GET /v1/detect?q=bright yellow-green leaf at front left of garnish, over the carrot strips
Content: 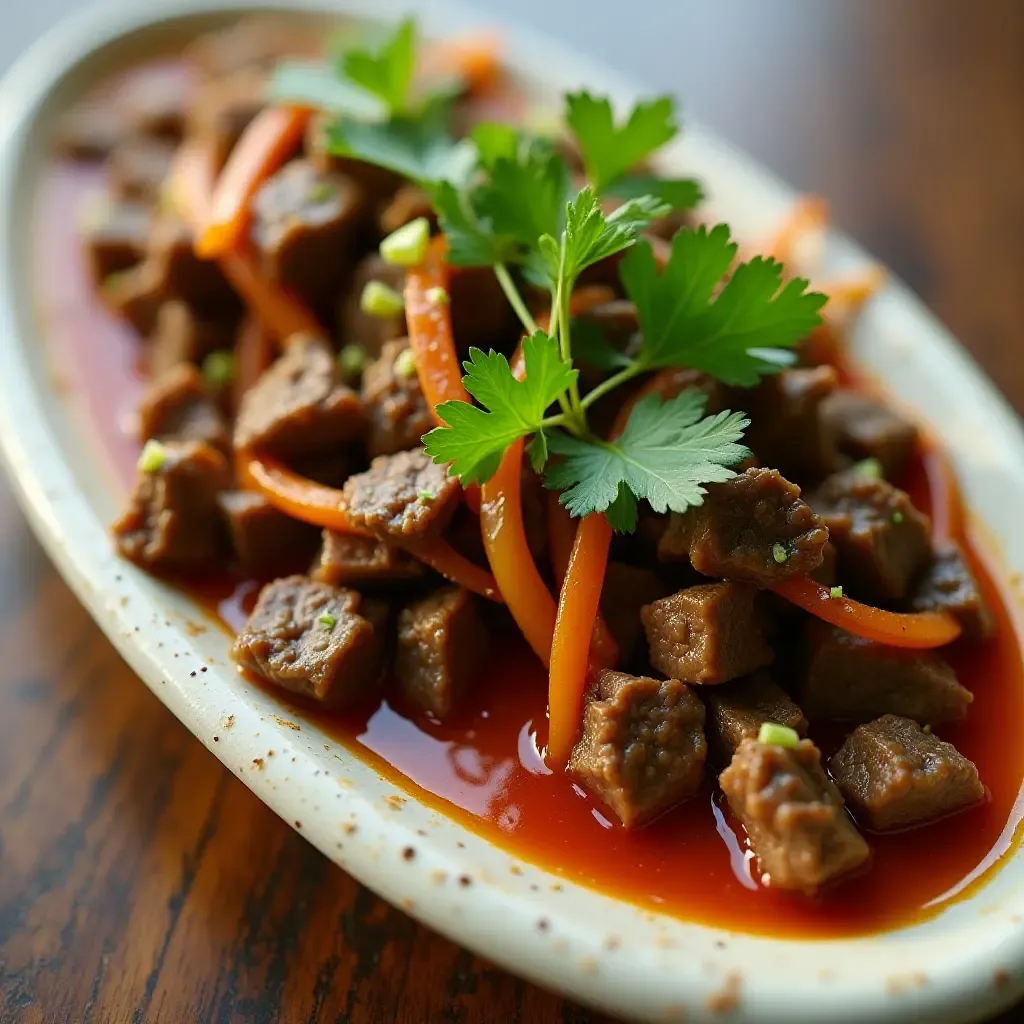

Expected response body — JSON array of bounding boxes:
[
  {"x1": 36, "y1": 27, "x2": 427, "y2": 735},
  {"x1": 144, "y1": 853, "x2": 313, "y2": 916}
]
[{"x1": 423, "y1": 331, "x2": 577, "y2": 483}]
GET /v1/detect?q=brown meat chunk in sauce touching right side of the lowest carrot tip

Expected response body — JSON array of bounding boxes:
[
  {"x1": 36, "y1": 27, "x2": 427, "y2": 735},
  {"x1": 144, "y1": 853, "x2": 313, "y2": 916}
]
[{"x1": 568, "y1": 672, "x2": 708, "y2": 828}]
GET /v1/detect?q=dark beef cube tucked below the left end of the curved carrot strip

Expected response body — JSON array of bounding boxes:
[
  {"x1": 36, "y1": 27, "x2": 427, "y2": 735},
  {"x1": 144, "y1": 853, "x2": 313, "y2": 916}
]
[{"x1": 211, "y1": 490, "x2": 319, "y2": 574}]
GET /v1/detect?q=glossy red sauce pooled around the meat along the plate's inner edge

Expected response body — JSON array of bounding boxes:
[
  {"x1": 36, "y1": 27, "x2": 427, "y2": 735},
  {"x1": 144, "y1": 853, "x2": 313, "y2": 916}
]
[{"x1": 34, "y1": 166, "x2": 1024, "y2": 936}]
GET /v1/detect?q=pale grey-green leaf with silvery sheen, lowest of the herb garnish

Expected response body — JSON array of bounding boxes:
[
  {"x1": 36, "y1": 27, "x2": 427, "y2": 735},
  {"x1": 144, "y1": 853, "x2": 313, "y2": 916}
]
[{"x1": 544, "y1": 390, "x2": 750, "y2": 532}]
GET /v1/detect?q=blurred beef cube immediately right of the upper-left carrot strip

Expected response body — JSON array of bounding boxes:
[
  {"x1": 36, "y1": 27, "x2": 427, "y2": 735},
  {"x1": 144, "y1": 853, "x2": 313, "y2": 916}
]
[{"x1": 253, "y1": 160, "x2": 364, "y2": 310}]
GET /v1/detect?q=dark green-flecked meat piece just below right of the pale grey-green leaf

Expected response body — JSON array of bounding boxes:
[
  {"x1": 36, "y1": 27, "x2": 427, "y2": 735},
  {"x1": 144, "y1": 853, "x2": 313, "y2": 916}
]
[{"x1": 657, "y1": 468, "x2": 828, "y2": 587}]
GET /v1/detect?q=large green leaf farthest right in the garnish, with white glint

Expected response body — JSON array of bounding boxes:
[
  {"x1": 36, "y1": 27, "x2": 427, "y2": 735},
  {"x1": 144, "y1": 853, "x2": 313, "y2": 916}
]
[{"x1": 620, "y1": 224, "x2": 826, "y2": 387}]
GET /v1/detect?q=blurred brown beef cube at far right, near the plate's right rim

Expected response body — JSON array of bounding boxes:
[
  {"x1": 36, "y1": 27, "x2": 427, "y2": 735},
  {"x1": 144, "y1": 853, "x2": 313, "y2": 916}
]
[{"x1": 821, "y1": 390, "x2": 918, "y2": 479}]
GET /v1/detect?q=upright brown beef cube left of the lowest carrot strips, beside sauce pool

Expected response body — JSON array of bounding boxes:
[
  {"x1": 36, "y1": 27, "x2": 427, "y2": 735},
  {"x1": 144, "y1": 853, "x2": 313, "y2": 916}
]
[{"x1": 394, "y1": 587, "x2": 487, "y2": 719}]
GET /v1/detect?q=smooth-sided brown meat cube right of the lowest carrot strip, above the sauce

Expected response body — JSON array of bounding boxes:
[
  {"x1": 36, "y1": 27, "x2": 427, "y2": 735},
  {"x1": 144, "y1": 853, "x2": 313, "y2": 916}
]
[{"x1": 640, "y1": 583, "x2": 774, "y2": 685}]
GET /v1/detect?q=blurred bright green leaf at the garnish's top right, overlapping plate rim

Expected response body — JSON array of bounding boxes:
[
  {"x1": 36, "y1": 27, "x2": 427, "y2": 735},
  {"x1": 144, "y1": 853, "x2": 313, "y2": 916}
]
[{"x1": 565, "y1": 92, "x2": 679, "y2": 193}]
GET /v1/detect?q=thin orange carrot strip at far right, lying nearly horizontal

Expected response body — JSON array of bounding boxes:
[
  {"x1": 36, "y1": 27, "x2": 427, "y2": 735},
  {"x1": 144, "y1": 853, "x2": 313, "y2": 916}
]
[{"x1": 771, "y1": 577, "x2": 961, "y2": 648}]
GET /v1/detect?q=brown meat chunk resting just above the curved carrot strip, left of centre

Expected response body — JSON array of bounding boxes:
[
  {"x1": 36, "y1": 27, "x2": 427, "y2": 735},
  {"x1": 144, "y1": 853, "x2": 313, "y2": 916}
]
[{"x1": 234, "y1": 335, "x2": 364, "y2": 459}]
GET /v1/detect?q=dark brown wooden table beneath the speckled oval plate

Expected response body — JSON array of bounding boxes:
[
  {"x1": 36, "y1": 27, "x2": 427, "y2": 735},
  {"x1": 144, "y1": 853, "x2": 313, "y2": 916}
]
[{"x1": 0, "y1": 0, "x2": 1024, "y2": 1024}]
